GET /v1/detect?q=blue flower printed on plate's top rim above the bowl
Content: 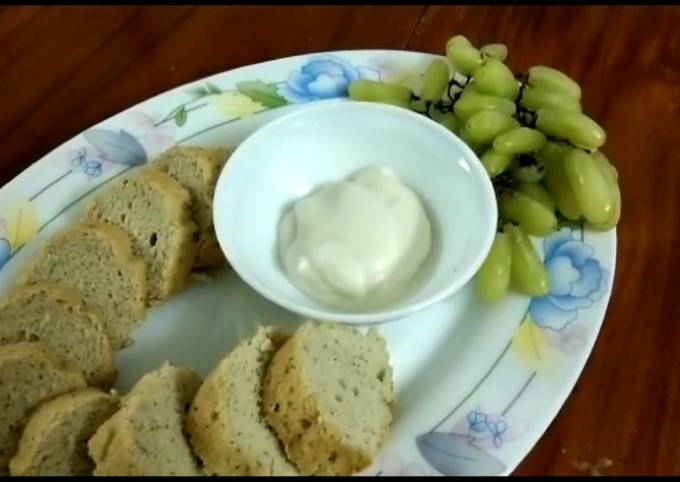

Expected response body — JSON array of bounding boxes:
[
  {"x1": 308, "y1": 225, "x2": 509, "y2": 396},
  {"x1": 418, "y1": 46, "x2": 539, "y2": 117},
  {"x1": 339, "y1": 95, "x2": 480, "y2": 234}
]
[{"x1": 279, "y1": 55, "x2": 380, "y2": 104}]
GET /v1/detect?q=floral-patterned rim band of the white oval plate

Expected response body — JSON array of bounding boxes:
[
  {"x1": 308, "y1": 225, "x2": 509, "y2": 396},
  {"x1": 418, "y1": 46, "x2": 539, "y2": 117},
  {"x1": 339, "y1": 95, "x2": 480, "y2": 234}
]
[{"x1": 0, "y1": 52, "x2": 615, "y2": 475}]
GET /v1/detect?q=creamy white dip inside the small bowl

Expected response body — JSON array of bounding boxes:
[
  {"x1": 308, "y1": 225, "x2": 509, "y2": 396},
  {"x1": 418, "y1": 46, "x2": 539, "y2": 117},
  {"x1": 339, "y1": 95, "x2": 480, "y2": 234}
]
[{"x1": 279, "y1": 166, "x2": 432, "y2": 308}]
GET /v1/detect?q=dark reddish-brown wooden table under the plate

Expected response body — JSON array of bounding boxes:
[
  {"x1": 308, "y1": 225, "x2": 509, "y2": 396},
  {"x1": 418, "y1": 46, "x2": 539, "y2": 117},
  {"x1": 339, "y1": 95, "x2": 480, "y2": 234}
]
[{"x1": 0, "y1": 6, "x2": 680, "y2": 475}]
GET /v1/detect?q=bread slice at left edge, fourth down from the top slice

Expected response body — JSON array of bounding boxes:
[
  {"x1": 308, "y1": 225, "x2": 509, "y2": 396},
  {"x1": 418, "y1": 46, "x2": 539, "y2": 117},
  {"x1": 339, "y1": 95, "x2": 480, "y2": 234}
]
[{"x1": 0, "y1": 284, "x2": 117, "y2": 388}]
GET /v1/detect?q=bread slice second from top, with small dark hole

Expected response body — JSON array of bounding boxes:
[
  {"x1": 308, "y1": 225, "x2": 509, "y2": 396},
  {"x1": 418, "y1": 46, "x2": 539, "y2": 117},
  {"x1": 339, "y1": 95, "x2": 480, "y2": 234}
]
[{"x1": 85, "y1": 167, "x2": 196, "y2": 305}]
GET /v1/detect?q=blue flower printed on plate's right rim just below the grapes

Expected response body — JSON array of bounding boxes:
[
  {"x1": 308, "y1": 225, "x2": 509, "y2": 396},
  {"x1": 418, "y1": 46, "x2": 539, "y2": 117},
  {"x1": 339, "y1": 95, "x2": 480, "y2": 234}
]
[{"x1": 529, "y1": 228, "x2": 609, "y2": 331}]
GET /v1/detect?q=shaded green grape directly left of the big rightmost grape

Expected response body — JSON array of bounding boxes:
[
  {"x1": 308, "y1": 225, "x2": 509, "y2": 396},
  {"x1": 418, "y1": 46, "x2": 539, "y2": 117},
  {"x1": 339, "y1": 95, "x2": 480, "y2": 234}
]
[{"x1": 537, "y1": 142, "x2": 581, "y2": 221}]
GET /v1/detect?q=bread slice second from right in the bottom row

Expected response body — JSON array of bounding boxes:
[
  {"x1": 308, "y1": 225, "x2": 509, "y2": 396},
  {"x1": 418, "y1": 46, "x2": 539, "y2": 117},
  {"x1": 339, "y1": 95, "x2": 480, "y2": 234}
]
[{"x1": 187, "y1": 328, "x2": 296, "y2": 476}]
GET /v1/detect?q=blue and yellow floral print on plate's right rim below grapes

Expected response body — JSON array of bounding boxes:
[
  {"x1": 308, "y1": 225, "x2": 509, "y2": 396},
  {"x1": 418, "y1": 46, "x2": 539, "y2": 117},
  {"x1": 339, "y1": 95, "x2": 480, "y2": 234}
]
[{"x1": 416, "y1": 226, "x2": 608, "y2": 476}]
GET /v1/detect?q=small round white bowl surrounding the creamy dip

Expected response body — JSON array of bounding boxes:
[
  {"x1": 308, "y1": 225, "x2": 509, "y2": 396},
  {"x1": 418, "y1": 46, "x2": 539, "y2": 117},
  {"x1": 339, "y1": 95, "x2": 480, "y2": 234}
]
[{"x1": 214, "y1": 100, "x2": 497, "y2": 324}]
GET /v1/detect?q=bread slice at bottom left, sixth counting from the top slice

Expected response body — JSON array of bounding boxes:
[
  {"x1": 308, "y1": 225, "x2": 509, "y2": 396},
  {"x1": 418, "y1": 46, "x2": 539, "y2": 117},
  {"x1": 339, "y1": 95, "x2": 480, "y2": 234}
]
[{"x1": 9, "y1": 388, "x2": 118, "y2": 476}]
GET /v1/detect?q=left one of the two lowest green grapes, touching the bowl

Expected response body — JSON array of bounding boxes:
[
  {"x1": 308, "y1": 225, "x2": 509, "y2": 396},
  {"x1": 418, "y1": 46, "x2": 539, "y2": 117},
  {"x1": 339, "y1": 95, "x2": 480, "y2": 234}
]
[{"x1": 476, "y1": 233, "x2": 512, "y2": 301}]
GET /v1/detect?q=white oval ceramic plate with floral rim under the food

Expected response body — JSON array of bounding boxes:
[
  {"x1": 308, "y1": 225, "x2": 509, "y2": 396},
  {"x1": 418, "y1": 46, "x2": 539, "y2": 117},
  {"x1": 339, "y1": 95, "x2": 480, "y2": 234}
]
[{"x1": 0, "y1": 50, "x2": 616, "y2": 475}]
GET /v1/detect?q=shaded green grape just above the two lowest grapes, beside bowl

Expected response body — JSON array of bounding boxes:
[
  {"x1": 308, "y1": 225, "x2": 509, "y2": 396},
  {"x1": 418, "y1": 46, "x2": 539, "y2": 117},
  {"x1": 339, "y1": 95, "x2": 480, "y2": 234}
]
[{"x1": 499, "y1": 192, "x2": 557, "y2": 236}]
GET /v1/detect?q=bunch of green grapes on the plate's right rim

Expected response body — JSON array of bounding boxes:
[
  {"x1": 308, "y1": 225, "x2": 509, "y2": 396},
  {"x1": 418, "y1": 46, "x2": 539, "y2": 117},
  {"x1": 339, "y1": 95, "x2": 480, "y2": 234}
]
[{"x1": 349, "y1": 35, "x2": 621, "y2": 301}]
